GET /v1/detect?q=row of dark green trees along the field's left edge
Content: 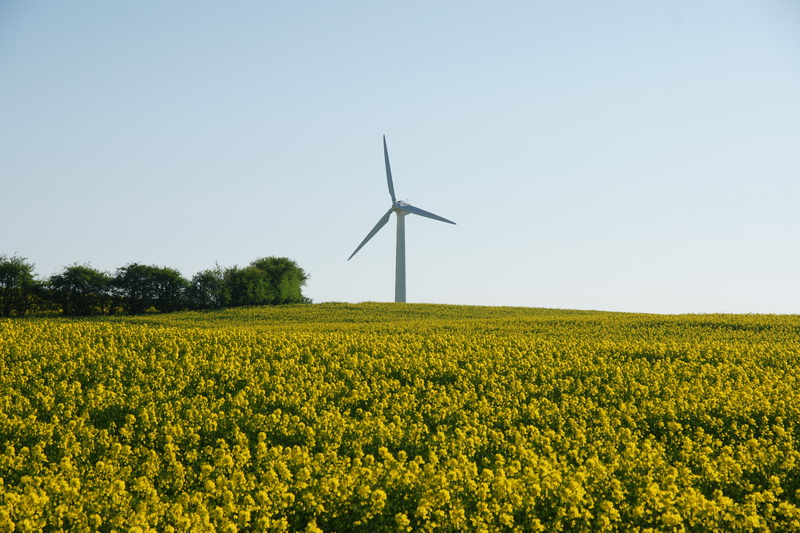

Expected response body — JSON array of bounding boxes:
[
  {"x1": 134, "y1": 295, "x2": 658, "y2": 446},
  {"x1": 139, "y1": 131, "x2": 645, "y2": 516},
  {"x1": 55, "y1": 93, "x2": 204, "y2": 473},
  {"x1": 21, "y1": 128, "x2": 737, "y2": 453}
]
[{"x1": 0, "y1": 254, "x2": 310, "y2": 317}]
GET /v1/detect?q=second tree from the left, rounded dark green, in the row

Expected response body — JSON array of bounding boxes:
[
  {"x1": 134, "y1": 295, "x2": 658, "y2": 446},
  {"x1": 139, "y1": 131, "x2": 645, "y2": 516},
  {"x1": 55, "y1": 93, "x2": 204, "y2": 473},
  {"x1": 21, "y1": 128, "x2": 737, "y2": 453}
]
[{"x1": 50, "y1": 264, "x2": 111, "y2": 316}]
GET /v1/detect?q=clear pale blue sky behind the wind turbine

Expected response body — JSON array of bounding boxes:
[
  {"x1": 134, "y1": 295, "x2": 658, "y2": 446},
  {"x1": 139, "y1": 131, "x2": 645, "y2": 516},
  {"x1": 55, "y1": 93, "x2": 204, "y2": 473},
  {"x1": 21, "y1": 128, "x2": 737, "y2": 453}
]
[{"x1": 0, "y1": 0, "x2": 800, "y2": 313}]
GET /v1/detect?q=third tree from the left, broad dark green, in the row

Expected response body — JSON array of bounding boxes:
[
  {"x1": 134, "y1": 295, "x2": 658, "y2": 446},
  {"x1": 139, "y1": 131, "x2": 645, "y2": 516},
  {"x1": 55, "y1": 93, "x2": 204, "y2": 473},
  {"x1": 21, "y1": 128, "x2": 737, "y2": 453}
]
[{"x1": 114, "y1": 263, "x2": 188, "y2": 315}]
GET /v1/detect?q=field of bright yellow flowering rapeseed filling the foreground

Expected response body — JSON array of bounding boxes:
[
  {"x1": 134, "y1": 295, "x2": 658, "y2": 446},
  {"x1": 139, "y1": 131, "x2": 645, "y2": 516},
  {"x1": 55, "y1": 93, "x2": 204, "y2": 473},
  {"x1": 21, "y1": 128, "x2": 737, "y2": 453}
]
[{"x1": 0, "y1": 304, "x2": 800, "y2": 532}]
